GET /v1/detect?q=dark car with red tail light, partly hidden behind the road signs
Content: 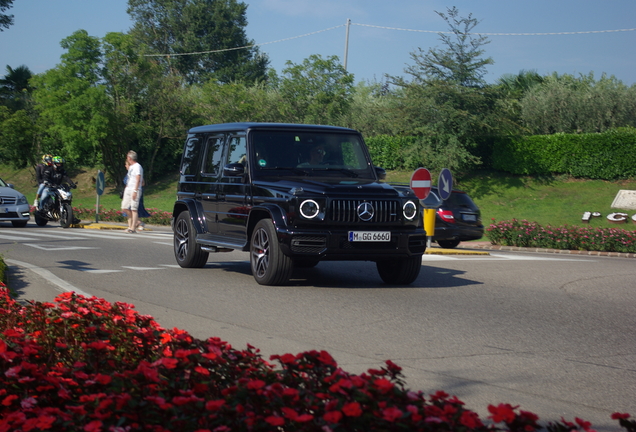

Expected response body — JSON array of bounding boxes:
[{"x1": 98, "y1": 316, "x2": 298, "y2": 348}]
[{"x1": 431, "y1": 187, "x2": 484, "y2": 248}]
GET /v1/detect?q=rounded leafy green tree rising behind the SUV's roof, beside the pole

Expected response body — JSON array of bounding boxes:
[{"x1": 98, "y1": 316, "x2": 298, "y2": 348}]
[{"x1": 279, "y1": 54, "x2": 353, "y2": 124}]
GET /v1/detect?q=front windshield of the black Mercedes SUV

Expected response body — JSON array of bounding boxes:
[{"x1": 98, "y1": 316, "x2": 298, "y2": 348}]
[{"x1": 250, "y1": 130, "x2": 375, "y2": 179}]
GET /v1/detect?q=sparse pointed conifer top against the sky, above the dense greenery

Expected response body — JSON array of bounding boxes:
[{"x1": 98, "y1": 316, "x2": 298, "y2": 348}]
[{"x1": 406, "y1": 6, "x2": 494, "y2": 87}]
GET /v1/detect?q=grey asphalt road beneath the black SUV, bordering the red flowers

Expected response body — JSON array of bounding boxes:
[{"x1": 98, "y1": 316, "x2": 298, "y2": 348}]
[{"x1": 0, "y1": 223, "x2": 636, "y2": 431}]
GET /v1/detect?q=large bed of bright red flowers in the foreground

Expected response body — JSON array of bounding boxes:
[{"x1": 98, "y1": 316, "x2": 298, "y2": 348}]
[{"x1": 0, "y1": 285, "x2": 636, "y2": 432}]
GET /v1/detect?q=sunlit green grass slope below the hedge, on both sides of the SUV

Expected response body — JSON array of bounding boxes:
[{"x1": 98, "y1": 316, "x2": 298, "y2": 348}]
[{"x1": 0, "y1": 166, "x2": 636, "y2": 233}]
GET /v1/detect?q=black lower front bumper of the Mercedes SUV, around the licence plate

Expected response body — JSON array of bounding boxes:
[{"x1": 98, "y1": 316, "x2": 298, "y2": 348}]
[{"x1": 278, "y1": 228, "x2": 426, "y2": 261}]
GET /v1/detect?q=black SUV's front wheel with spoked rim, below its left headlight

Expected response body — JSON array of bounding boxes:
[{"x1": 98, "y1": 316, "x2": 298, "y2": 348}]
[{"x1": 250, "y1": 219, "x2": 294, "y2": 285}]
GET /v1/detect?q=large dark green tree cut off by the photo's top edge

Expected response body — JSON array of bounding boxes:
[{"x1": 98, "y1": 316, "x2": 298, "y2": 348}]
[{"x1": 128, "y1": 0, "x2": 269, "y2": 84}]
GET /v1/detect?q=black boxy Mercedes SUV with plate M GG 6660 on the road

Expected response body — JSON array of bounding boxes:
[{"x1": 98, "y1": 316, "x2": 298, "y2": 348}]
[{"x1": 172, "y1": 123, "x2": 426, "y2": 285}]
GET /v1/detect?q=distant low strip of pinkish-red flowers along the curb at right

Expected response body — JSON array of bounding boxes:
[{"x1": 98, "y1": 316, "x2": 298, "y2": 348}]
[{"x1": 487, "y1": 219, "x2": 636, "y2": 253}]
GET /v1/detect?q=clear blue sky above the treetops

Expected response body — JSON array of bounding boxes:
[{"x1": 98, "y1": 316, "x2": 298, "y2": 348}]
[{"x1": 0, "y1": 0, "x2": 636, "y2": 85}]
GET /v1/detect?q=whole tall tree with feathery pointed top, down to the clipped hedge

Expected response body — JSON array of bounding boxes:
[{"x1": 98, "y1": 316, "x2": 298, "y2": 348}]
[{"x1": 389, "y1": 7, "x2": 497, "y2": 171}]
